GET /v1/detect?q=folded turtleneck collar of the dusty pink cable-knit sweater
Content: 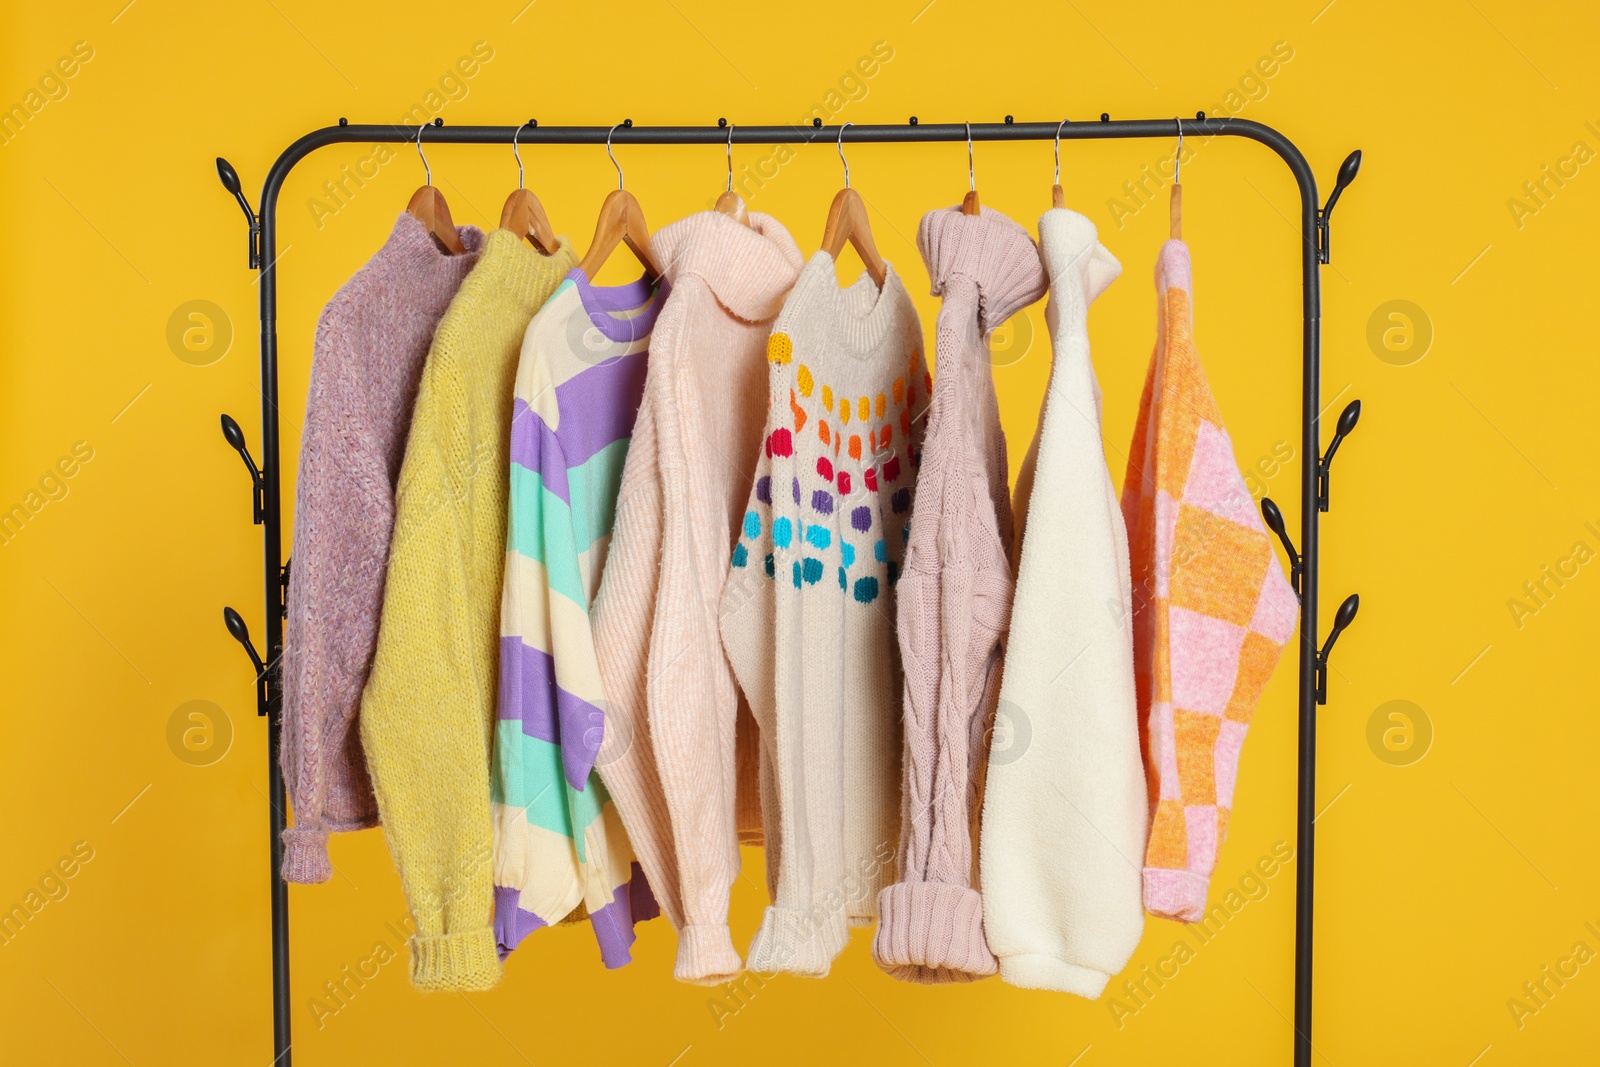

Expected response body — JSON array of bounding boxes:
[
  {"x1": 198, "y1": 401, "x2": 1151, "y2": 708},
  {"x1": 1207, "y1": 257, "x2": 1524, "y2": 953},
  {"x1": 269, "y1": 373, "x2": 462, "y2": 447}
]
[{"x1": 917, "y1": 208, "x2": 1045, "y2": 333}]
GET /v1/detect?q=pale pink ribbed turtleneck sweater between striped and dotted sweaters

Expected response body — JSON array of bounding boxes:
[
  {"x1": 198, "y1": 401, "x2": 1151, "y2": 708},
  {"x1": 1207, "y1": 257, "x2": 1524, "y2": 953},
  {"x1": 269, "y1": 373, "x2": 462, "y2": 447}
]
[{"x1": 592, "y1": 211, "x2": 803, "y2": 984}]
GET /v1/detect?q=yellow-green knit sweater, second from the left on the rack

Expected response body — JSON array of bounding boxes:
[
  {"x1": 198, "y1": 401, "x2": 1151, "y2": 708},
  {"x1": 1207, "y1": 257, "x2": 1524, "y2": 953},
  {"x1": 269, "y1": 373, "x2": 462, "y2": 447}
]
[{"x1": 360, "y1": 230, "x2": 578, "y2": 990}]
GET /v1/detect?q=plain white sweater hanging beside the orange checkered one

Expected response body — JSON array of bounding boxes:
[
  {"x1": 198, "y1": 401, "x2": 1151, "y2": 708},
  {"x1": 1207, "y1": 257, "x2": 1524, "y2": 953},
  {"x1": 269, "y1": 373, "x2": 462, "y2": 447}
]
[{"x1": 979, "y1": 208, "x2": 1149, "y2": 998}]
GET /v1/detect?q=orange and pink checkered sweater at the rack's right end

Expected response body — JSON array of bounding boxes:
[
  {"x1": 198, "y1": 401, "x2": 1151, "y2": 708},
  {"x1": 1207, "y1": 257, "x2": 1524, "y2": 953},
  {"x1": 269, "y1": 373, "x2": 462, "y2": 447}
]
[{"x1": 1122, "y1": 242, "x2": 1298, "y2": 923}]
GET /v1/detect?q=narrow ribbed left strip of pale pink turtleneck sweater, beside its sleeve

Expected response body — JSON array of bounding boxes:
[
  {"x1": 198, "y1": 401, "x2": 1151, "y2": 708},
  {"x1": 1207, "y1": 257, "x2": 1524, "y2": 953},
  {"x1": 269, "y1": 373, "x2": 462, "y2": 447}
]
[{"x1": 590, "y1": 397, "x2": 683, "y2": 929}]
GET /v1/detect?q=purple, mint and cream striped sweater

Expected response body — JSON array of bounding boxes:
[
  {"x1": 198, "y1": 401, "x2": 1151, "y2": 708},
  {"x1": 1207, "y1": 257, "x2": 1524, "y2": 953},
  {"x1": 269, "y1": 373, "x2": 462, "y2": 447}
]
[{"x1": 491, "y1": 270, "x2": 666, "y2": 968}]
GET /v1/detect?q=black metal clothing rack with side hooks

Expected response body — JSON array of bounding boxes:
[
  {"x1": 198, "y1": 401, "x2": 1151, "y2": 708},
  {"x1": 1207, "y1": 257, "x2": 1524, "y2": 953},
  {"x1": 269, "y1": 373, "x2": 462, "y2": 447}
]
[{"x1": 216, "y1": 112, "x2": 1362, "y2": 1067}]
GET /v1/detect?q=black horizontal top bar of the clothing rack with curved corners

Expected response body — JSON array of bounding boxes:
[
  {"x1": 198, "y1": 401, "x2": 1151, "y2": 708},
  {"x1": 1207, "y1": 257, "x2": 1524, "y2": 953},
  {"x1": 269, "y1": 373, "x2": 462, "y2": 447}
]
[{"x1": 262, "y1": 115, "x2": 1317, "y2": 214}]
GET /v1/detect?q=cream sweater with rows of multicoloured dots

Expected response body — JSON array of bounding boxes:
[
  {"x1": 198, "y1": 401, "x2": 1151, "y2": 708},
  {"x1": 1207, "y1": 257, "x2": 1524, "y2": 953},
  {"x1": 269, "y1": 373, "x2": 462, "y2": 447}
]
[{"x1": 720, "y1": 253, "x2": 931, "y2": 976}]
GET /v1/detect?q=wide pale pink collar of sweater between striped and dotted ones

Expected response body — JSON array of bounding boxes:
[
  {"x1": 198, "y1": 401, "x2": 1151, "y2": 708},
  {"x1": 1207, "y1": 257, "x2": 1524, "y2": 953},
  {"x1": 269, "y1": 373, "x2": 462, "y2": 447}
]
[{"x1": 650, "y1": 211, "x2": 805, "y2": 322}]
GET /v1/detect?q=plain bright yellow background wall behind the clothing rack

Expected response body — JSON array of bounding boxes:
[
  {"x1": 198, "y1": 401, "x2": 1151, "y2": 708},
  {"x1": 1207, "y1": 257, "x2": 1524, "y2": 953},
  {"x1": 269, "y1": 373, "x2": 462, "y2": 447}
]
[{"x1": 0, "y1": 0, "x2": 1600, "y2": 1067}]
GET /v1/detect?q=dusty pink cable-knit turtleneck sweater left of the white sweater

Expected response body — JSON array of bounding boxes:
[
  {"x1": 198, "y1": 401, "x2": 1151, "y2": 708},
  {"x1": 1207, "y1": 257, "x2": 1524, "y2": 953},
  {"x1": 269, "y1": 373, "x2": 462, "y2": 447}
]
[{"x1": 872, "y1": 208, "x2": 1046, "y2": 984}]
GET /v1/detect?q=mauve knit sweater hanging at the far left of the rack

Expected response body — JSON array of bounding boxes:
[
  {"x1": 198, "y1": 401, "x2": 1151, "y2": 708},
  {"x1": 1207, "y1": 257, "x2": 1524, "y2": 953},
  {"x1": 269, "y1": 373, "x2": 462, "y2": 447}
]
[{"x1": 280, "y1": 214, "x2": 483, "y2": 883}]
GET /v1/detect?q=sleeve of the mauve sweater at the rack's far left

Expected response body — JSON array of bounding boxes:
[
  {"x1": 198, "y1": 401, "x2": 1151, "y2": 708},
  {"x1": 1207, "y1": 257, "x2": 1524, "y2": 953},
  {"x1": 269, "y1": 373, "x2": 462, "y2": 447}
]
[{"x1": 280, "y1": 309, "x2": 384, "y2": 885}]
